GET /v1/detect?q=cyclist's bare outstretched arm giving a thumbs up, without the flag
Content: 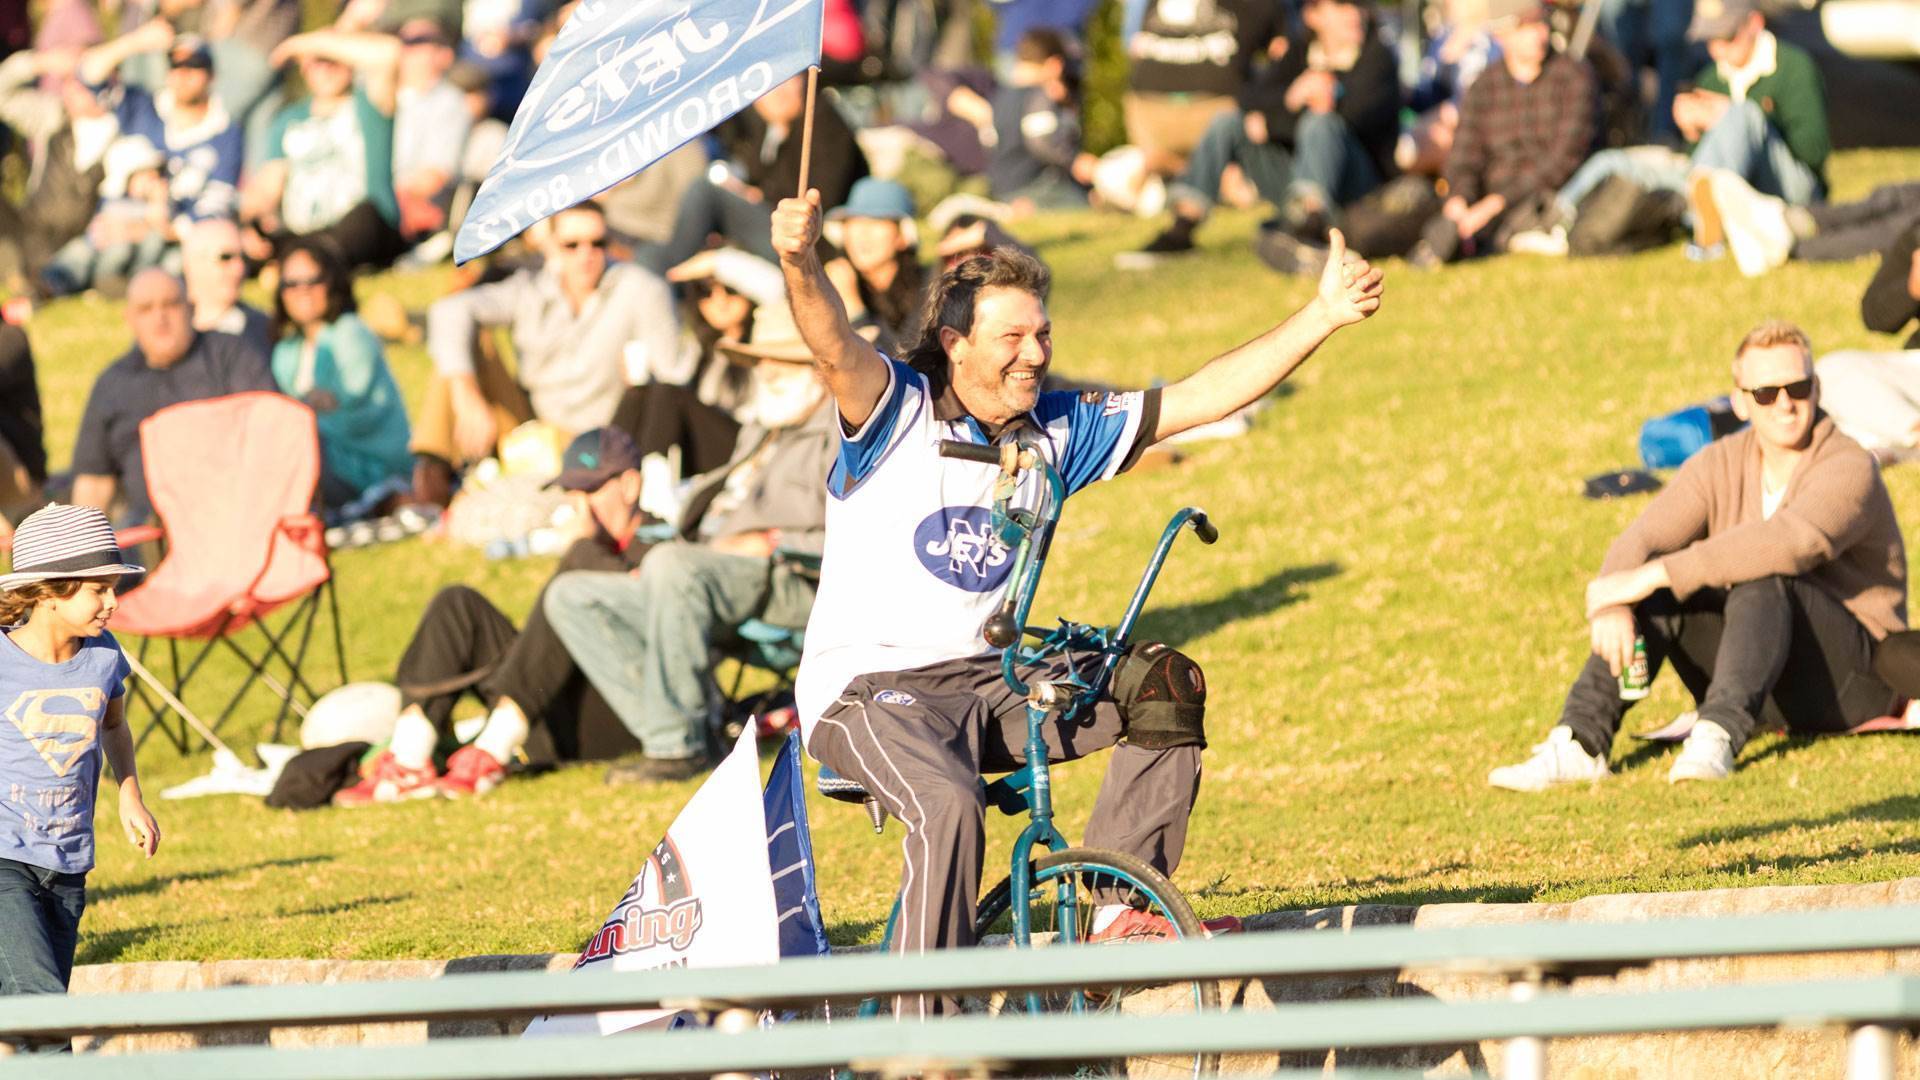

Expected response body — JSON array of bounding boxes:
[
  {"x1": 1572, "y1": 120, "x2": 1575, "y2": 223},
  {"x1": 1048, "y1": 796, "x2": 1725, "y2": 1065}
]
[{"x1": 1154, "y1": 229, "x2": 1386, "y2": 442}]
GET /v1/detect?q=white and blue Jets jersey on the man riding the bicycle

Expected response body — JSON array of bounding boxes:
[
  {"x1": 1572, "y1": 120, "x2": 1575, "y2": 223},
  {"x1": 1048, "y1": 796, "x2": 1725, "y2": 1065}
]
[{"x1": 795, "y1": 359, "x2": 1160, "y2": 736}]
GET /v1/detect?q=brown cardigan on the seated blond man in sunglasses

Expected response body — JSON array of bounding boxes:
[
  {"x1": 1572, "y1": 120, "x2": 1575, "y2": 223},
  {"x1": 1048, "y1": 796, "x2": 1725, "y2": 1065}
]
[{"x1": 1599, "y1": 413, "x2": 1907, "y2": 640}]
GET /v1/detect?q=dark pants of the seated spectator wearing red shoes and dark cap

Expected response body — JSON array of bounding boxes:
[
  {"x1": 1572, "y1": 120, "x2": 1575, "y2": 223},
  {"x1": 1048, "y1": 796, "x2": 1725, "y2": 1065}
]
[{"x1": 396, "y1": 540, "x2": 639, "y2": 763}]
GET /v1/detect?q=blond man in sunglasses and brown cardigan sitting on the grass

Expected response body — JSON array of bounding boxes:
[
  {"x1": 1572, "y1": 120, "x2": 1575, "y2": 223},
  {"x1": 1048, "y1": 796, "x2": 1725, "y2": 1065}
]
[{"x1": 1488, "y1": 321, "x2": 1907, "y2": 792}]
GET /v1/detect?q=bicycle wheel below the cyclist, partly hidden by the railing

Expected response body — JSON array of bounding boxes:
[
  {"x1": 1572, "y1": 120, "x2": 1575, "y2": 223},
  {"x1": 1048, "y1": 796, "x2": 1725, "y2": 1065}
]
[{"x1": 960, "y1": 847, "x2": 1219, "y2": 1080}]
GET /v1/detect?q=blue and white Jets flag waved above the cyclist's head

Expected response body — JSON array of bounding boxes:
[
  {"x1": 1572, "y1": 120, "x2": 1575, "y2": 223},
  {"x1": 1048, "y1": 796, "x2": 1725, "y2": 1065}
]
[{"x1": 464, "y1": 0, "x2": 826, "y2": 263}]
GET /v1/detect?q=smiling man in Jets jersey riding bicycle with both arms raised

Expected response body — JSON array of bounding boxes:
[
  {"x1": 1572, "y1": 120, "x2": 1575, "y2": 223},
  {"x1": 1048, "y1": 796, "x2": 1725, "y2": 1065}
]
[{"x1": 772, "y1": 192, "x2": 1382, "y2": 976}]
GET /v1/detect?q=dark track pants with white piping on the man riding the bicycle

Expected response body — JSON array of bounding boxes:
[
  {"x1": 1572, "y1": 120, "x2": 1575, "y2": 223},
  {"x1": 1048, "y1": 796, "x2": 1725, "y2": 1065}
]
[{"x1": 806, "y1": 655, "x2": 1200, "y2": 1006}]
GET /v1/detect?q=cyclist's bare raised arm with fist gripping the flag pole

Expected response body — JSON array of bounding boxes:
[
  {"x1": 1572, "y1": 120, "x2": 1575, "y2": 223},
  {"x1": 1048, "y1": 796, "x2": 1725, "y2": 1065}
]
[{"x1": 774, "y1": 190, "x2": 887, "y2": 427}]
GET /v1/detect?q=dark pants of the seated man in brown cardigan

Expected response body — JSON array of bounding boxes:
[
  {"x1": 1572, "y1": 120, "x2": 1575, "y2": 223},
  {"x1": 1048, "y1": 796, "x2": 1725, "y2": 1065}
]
[{"x1": 1561, "y1": 577, "x2": 1895, "y2": 757}]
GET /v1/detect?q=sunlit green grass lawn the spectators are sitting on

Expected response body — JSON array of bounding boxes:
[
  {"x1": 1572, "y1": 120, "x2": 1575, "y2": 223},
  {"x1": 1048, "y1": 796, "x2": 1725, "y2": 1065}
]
[{"x1": 31, "y1": 152, "x2": 1920, "y2": 963}]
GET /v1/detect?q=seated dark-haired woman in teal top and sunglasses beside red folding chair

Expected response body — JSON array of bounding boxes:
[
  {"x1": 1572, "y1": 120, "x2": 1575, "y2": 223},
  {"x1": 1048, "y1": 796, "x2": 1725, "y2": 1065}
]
[{"x1": 273, "y1": 238, "x2": 413, "y2": 517}]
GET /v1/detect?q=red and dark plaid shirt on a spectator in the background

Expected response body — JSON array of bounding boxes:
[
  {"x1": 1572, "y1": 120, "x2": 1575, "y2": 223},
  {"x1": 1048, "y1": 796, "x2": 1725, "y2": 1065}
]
[{"x1": 1446, "y1": 54, "x2": 1599, "y2": 206}]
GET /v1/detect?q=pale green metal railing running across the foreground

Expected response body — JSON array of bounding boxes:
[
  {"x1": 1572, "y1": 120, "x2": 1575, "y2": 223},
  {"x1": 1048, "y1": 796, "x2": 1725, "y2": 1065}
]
[{"x1": 0, "y1": 907, "x2": 1920, "y2": 1080}]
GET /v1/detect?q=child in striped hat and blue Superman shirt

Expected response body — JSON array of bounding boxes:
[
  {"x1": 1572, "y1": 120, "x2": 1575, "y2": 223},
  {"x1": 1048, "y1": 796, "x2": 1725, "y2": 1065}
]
[{"x1": 0, "y1": 503, "x2": 159, "y2": 1045}]
